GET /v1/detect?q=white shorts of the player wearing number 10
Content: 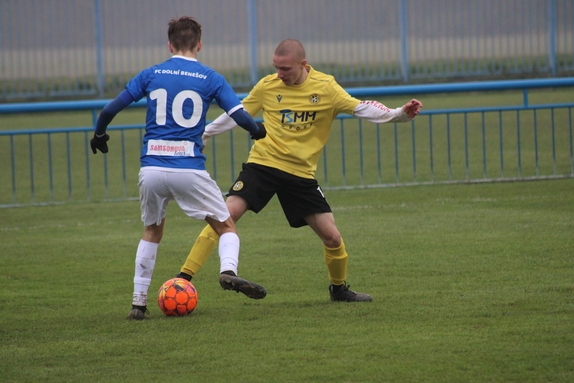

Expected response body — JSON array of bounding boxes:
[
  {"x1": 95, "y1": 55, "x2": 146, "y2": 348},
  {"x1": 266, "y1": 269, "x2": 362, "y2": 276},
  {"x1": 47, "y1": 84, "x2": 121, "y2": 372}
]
[{"x1": 138, "y1": 166, "x2": 230, "y2": 226}]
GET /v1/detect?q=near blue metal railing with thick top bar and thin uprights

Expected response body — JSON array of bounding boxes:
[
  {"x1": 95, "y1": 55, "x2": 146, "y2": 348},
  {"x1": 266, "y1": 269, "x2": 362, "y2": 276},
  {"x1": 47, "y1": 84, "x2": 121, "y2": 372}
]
[{"x1": 0, "y1": 78, "x2": 574, "y2": 206}]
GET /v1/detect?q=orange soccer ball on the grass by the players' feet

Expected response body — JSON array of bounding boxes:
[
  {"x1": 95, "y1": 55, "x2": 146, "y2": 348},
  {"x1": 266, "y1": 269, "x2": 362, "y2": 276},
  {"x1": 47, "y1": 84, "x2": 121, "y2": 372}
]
[{"x1": 157, "y1": 278, "x2": 197, "y2": 316}]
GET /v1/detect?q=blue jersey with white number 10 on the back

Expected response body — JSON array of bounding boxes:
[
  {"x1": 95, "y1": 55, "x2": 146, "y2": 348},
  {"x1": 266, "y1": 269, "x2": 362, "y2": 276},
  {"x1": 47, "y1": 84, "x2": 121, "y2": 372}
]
[{"x1": 126, "y1": 56, "x2": 242, "y2": 170}]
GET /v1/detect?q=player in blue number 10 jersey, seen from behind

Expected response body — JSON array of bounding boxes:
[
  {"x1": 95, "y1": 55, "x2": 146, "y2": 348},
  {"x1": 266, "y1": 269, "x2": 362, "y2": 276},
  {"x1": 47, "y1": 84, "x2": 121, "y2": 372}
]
[{"x1": 90, "y1": 16, "x2": 267, "y2": 319}]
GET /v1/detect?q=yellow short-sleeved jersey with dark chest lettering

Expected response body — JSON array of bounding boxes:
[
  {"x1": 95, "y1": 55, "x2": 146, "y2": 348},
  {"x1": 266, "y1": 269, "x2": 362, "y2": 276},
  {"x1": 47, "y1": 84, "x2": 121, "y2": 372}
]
[{"x1": 242, "y1": 65, "x2": 361, "y2": 178}]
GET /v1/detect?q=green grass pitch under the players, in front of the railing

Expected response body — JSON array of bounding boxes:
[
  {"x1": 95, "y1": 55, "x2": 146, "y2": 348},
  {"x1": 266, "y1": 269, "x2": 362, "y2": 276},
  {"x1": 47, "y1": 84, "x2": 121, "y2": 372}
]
[{"x1": 0, "y1": 179, "x2": 574, "y2": 382}]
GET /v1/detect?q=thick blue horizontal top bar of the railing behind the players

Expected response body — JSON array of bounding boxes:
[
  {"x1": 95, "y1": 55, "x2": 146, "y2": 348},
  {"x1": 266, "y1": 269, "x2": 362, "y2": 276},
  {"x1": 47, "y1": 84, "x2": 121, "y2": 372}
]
[{"x1": 0, "y1": 77, "x2": 574, "y2": 114}]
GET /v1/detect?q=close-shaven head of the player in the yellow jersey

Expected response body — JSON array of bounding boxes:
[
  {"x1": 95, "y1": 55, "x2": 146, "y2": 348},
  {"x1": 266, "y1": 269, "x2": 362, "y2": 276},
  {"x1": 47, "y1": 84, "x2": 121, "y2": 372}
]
[{"x1": 273, "y1": 39, "x2": 307, "y2": 85}]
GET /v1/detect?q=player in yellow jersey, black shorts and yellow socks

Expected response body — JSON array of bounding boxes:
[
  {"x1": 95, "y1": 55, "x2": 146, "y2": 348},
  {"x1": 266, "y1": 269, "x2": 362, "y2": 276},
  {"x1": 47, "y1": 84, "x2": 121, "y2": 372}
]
[{"x1": 178, "y1": 40, "x2": 422, "y2": 302}]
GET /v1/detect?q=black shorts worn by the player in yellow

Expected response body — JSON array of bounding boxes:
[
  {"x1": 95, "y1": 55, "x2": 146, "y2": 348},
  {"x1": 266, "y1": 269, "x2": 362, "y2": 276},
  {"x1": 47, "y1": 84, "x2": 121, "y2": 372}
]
[{"x1": 228, "y1": 163, "x2": 331, "y2": 227}]
